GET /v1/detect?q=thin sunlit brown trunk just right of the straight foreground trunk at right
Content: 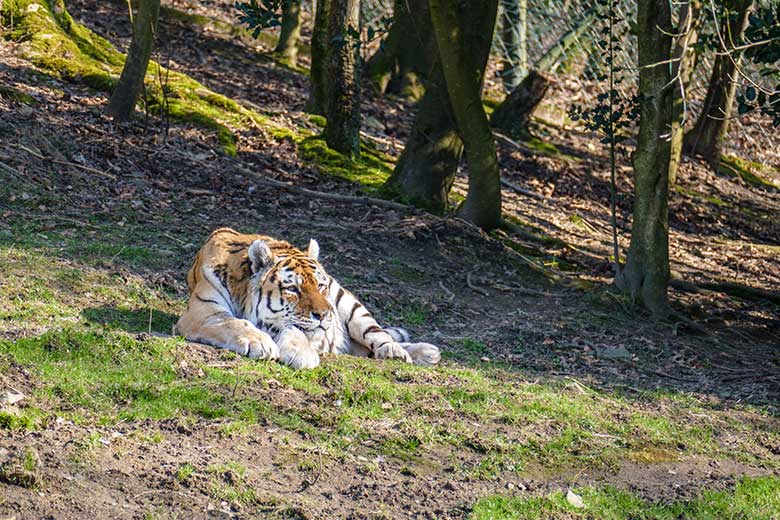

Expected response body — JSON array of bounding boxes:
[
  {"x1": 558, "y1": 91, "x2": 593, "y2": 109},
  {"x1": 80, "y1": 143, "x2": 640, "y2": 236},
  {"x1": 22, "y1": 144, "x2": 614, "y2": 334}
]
[{"x1": 669, "y1": 0, "x2": 701, "y2": 186}]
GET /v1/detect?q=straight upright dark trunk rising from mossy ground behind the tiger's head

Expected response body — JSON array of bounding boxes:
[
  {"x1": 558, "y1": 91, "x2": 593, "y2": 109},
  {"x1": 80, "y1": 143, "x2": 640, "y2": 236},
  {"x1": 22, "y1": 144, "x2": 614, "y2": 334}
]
[{"x1": 325, "y1": 0, "x2": 360, "y2": 157}]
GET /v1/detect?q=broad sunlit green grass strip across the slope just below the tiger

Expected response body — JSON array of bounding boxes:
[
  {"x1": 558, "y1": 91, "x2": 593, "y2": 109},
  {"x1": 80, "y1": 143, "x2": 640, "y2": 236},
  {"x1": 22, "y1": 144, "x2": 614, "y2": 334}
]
[{"x1": 0, "y1": 326, "x2": 780, "y2": 478}]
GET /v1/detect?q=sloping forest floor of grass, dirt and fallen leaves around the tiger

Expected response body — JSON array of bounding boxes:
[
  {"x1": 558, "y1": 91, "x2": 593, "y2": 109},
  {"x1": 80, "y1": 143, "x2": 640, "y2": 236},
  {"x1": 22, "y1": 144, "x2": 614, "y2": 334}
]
[{"x1": 0, "y1": 0, "x2": 780, "y2": 520}]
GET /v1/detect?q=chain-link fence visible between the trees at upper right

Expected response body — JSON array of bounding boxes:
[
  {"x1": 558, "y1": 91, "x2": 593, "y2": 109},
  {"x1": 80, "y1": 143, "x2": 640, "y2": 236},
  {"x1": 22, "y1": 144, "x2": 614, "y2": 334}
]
[{"x1": 361, "y1": 0, "x2": 776, "y2": 162}]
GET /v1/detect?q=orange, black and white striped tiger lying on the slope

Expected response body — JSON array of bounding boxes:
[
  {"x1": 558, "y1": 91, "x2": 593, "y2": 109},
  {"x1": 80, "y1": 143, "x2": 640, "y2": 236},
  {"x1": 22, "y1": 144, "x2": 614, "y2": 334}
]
[{"x1": 173, "y1": 228, "x2": 441, "y2": 369}]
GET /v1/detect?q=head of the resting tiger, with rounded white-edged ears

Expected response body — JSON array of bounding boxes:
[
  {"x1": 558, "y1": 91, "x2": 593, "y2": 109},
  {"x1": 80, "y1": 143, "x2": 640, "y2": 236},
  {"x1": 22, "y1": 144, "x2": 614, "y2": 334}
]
[{"x1": 248, "y1": 240, "x2": 334, "y2": 335}]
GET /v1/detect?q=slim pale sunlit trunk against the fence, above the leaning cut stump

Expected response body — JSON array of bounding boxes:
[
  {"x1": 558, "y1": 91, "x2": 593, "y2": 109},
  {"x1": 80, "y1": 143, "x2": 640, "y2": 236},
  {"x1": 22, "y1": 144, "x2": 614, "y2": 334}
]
[{"x1": 501, "y1": 0, "x2": 528, "y2": 92}]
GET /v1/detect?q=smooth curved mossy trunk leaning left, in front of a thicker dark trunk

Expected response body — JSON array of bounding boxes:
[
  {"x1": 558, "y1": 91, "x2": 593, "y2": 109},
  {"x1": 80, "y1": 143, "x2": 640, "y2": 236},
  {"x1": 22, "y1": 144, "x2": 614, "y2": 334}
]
[{"x1": 430, "y1": 0, "x2": 501, "y2": 229}]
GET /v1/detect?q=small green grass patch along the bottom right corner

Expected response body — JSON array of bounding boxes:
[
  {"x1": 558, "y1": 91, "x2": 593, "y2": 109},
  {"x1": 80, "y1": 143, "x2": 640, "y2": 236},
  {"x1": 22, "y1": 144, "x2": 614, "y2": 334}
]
[{"x1": 469, "y1": 477, "x2": 780, "y2": 520}]
